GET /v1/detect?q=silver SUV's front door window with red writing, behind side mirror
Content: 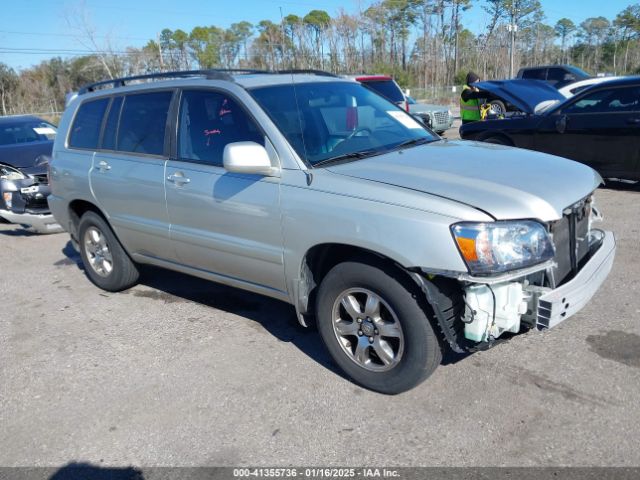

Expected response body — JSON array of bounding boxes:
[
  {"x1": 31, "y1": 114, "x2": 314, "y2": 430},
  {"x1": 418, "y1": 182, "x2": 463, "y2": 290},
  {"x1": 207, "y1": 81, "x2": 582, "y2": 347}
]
[{"x1": 178, "y1": 90, "x2": 265, "y2": 167}]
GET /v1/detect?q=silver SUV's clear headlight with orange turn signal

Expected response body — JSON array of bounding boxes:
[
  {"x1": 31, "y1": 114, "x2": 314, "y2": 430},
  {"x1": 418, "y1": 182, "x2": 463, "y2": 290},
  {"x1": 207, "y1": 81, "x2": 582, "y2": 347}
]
[{"x1": 451, "y1": 220, "x2": 555, "y2": 275}]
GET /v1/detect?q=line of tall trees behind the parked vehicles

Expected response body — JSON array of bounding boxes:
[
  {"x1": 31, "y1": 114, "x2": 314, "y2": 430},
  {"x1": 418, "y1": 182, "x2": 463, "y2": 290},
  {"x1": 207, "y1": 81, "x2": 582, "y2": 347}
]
[{"x1": 0, "y1": 0, "x2": 640, "y2": 115}]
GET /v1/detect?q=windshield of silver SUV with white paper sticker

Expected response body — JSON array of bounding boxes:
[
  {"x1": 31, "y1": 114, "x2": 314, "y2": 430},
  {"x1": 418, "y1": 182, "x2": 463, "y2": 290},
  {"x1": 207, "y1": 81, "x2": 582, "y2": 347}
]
[{"x1": 251, "y1": 82, "x2": 438, "y2": 165}]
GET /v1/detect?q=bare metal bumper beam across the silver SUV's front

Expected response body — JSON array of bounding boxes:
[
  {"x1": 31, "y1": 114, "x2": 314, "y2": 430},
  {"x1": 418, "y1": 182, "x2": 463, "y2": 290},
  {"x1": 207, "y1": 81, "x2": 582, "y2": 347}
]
[{"x1": 537, "y1": 232, "x2": 616, "y2": 330}]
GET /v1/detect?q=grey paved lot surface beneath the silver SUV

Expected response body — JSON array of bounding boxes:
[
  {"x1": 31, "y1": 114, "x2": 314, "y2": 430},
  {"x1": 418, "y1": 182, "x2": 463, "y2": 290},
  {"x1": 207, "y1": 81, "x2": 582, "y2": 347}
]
[{"x1": 0, "y1": 147, "x2": 640, "y2": 466}]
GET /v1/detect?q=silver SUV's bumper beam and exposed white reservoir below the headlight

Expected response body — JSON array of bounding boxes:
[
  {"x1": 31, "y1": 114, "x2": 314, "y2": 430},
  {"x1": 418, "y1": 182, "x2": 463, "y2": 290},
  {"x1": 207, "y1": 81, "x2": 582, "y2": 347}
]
[{"x1": 412, "y1": 230, "x2": 616, "y2": 353}]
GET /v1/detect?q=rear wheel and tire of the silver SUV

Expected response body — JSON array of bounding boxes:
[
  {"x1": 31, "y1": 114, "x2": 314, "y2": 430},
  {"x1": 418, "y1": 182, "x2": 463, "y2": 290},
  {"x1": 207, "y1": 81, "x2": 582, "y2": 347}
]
[{"x1": 78, "y1": 212, "x2": 140, "y2": 292}]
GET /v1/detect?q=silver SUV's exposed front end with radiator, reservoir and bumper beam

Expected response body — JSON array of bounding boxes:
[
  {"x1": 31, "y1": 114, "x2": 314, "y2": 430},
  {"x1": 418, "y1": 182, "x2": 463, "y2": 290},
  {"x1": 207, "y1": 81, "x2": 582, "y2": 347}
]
[{"x1": 421, "y1": 196, "x2": 616, "y2": 352}]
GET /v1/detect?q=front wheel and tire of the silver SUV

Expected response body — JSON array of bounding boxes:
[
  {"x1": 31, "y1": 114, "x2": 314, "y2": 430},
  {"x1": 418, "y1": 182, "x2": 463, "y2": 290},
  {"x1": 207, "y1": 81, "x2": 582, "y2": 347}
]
[{"x1": 316, "y1": 261, "x2": 442, "y2": 394}]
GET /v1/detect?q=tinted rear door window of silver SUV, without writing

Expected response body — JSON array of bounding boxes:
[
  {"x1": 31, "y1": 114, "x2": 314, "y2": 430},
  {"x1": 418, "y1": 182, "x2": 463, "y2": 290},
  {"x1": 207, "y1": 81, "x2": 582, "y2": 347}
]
[{"x1": 117, "y1": 91, "x2": 173, "y2": 155}]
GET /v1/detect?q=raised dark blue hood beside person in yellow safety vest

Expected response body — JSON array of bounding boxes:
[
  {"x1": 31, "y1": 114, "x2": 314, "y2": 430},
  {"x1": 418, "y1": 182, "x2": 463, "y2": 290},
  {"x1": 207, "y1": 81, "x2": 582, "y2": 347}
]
[{"x1": 473, "y1": 80, "x2": 566, "y2": 113}]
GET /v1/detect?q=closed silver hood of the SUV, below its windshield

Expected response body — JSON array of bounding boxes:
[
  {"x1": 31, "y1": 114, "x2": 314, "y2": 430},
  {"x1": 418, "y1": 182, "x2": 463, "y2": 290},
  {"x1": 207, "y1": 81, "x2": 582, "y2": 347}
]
[{"x1": 327, "y1": 140, "x2": 602, "y2": 222}]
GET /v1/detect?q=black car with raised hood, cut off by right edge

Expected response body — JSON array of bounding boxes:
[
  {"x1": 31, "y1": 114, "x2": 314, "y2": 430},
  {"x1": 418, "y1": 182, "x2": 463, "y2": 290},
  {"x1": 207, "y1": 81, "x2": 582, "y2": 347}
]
[{"x1": 460, "y1": 77, "x2": 640, "y2": 180}]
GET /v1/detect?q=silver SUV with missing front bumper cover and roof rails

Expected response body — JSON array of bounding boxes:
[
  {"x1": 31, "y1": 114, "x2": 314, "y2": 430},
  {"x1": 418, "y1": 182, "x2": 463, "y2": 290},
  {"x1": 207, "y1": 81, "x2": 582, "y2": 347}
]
[{"x1": 49, "y1": 71, "x2": 615, "y2": 393}]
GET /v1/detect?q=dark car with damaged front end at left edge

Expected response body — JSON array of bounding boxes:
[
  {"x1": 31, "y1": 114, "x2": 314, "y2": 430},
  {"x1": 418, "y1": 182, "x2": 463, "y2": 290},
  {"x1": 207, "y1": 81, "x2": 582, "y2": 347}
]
[{"x1": 0, "y1": 115, "x2": 59, "y2": 232}]
